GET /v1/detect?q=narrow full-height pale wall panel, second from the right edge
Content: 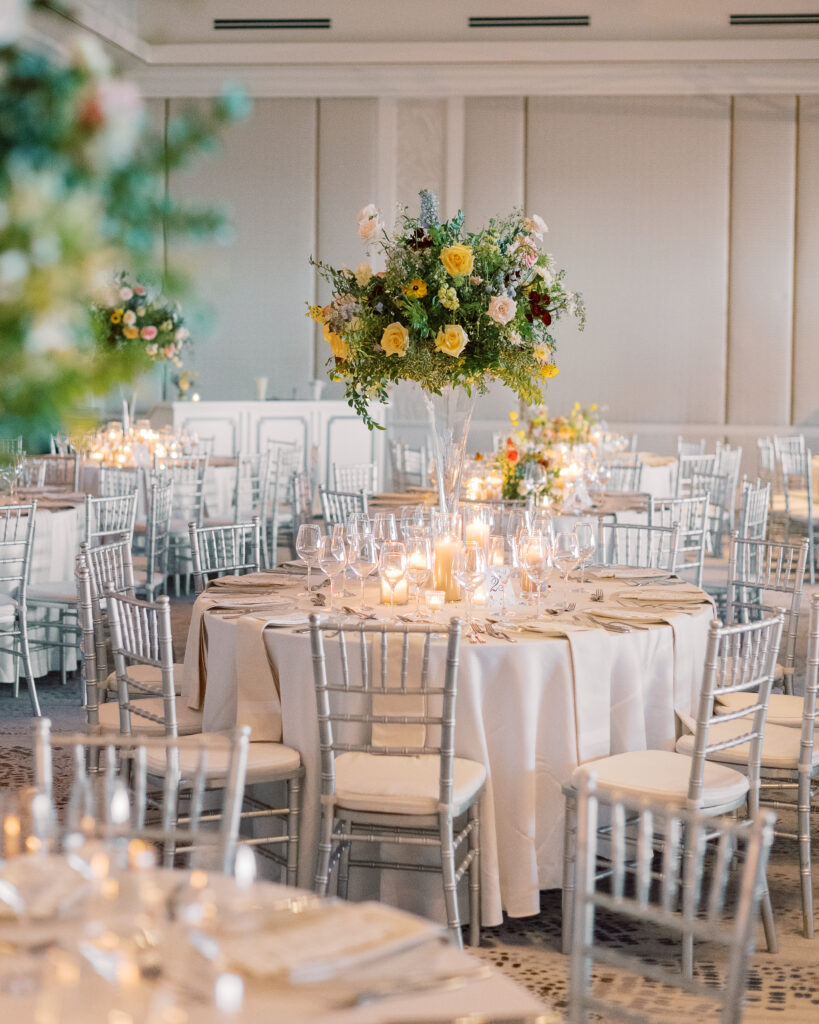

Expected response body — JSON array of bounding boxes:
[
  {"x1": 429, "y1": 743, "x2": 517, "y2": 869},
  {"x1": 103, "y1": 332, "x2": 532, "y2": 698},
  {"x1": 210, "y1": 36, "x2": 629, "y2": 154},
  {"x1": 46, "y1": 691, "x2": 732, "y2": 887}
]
[{"x1": 728, "y1": 96, "x2": 795, "y2": 423}]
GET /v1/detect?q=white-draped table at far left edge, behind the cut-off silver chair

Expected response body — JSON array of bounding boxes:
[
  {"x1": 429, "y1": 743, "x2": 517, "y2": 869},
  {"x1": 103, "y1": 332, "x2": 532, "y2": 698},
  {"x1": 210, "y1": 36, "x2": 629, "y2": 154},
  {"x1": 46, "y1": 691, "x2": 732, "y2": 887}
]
[{"x1": 0, "y1": 494, "x2": 85, "y2": 688}]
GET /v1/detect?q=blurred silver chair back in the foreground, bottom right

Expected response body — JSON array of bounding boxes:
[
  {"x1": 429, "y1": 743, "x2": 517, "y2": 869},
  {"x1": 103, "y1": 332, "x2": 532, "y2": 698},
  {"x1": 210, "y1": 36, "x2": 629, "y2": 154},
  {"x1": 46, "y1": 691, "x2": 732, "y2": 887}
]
[{"x1": 567, "y1": 773, "x2": 774, "y2": 1024}]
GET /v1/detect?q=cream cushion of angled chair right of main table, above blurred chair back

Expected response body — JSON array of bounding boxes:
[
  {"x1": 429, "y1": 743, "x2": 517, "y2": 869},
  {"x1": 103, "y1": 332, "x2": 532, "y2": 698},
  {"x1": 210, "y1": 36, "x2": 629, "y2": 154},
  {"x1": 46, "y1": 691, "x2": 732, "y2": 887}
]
[{"x1": 571, "y1": 751, "x2": 748, "y2": 810}]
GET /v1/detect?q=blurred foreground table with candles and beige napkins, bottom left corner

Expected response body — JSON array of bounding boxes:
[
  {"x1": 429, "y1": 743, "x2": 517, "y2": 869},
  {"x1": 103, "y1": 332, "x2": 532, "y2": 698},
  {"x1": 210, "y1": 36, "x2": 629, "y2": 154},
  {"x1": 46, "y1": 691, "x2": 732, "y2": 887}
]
[{"x1": 0, "y1": 855, "x2": 558, "y2": 1024}]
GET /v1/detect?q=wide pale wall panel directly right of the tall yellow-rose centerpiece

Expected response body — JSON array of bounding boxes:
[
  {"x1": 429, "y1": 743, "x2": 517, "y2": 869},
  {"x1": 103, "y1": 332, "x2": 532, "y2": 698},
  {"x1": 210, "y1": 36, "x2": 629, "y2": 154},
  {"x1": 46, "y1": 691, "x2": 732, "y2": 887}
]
[{"x1": 525, "y1": 97, "x2": 730, "y2": 423}]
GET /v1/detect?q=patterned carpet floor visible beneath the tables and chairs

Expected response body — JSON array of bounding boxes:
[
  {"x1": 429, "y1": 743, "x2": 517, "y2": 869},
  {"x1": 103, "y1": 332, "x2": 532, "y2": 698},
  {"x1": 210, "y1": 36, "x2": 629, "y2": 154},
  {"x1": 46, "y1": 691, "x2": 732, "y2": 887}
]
[{"x1": 0, "y1": 588, "x2": 819, "y2": 1024}]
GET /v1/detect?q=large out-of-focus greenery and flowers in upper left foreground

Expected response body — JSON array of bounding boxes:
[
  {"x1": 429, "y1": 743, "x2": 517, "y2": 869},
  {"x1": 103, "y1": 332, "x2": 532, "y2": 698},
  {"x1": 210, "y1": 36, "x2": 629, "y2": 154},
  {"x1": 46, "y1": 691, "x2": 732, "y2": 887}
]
[{"x1": 0, "y1": 0, "x2": 248, "y2": 451}]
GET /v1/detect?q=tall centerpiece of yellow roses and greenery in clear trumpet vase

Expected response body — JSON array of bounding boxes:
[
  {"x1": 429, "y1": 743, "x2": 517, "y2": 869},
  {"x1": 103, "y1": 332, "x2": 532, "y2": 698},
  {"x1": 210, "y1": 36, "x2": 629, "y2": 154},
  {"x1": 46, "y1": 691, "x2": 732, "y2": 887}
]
[{"x1": 309, "y1": 190, "x2": 584, "y2": 511}]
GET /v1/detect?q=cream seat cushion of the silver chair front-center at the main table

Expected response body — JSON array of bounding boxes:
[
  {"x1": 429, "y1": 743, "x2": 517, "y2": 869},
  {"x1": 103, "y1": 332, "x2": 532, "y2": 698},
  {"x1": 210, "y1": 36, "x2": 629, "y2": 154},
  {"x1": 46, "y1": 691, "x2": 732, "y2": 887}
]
[{"x1": 336, "y1": 752, "x2": 486, "y2": 814}]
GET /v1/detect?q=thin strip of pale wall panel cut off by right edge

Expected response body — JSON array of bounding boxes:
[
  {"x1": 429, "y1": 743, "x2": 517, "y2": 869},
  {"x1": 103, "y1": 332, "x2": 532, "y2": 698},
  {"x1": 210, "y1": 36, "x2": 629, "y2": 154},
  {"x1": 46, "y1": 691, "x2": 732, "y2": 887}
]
[{"x1": 793, "y1": 96, "x2": 819, "y2": 424}]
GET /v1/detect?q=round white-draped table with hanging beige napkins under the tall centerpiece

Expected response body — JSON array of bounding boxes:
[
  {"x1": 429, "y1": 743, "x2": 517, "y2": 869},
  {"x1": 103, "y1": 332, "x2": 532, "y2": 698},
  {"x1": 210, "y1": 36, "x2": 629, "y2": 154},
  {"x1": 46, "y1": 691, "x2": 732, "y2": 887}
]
[{"x1": 184, "y1": 574, "x2": 713, "y2": 925}]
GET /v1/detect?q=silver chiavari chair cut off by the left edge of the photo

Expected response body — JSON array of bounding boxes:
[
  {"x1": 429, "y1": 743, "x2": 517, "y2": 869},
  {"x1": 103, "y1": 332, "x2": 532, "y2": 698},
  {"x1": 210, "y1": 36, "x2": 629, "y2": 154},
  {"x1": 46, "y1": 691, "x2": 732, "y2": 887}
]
[{"x1": 0, "y1": 501, "x2": 40, "y2": 715}]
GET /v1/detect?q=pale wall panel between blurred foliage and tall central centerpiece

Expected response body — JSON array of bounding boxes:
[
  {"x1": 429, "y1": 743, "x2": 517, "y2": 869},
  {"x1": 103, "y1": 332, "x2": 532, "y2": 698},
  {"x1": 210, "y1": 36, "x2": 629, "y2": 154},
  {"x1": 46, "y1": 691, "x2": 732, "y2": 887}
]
[{"x1": 171, "y1": 99, "x2": 316, "y2": 398}]
